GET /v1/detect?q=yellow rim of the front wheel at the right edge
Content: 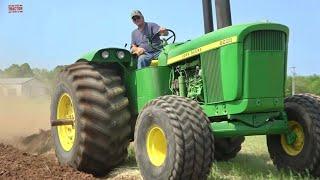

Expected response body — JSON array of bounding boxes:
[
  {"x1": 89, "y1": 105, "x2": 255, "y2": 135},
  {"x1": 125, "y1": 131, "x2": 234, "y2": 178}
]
[{"x1": 281, "y1": 121, "x2": 304, "y2": 156}]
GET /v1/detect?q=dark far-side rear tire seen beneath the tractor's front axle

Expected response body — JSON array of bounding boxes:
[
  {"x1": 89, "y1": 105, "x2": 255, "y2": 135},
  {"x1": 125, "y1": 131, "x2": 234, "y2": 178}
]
[{"x1": 214, "y1": 136, "x2": 245, "y2": 161}]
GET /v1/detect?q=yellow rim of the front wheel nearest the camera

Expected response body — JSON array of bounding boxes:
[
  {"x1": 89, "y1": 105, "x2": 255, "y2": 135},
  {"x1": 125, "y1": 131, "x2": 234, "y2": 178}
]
[{"x1": 146, "y1": 125, "x2": 167, "y2": 166}]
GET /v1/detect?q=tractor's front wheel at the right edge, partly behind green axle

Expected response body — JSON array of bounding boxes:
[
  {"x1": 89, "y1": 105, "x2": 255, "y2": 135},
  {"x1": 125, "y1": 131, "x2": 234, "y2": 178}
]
[{"x1": 267, "y1": 94, "x2": 320, "y2": 176}]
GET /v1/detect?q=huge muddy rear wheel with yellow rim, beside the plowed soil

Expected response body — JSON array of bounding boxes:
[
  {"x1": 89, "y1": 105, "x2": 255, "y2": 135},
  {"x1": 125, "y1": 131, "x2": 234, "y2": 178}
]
[{"x1": 51, "y1": 62, "x2": 131, "y2": 176}]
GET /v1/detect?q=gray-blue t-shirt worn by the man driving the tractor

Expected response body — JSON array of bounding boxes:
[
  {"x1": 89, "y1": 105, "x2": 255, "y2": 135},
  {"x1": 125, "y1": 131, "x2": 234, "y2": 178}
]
[{"x1": 131, "y1": 22, "x2": 161, "y2": 52}]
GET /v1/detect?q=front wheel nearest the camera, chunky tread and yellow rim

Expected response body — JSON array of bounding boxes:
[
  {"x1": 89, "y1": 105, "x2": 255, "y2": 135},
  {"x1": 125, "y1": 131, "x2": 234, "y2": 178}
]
[{"x1": 135, "y1": 96, "x2": 214, "y2": 180}]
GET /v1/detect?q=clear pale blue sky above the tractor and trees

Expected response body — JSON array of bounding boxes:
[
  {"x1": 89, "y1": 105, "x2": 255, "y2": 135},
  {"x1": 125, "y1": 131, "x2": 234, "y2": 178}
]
[{"x1": 0, "y1": 0, "x2": 320, "y2": 75}]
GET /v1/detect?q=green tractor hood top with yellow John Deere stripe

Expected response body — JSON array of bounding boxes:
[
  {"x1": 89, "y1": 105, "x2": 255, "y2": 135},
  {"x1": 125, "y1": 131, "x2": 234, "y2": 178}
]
[{"x1": 159, "y1": 23, "x2": 289, "y2": 66}]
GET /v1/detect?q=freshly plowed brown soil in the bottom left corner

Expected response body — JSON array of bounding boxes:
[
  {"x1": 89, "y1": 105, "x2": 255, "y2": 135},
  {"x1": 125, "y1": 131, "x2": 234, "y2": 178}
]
[{"x1": 0, "y1": 144, "x2": 94, "y2": 179}]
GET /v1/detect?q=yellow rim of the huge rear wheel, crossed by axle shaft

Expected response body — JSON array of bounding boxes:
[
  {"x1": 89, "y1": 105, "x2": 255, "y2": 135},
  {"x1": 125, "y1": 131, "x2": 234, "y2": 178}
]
[{"x1": 57, "y1": 93, "x2": 76, "y2": 151}]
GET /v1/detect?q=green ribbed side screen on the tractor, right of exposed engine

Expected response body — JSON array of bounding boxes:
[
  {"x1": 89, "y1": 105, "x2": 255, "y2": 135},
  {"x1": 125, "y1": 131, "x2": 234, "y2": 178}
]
[{"x1": 201, "y1": 49, "x2": 223, "y2": 103}]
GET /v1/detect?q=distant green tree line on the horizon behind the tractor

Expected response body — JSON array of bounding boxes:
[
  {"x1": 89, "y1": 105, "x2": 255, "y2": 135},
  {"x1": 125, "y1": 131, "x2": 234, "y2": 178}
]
[{"x1": 0, "y1": 63, "x2": 320, "y2": 96}]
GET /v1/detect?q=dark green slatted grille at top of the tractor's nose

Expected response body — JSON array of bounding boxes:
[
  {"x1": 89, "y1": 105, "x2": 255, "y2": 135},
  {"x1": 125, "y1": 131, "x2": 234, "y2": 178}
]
[{"x1": 245, "y1": 30, "x2": 286, "y2": 51}]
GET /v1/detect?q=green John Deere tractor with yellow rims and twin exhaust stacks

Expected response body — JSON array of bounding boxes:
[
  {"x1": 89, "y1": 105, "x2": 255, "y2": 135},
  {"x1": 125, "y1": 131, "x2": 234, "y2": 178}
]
[{"x1": 51, "y1": 0, "x2": 320, "y2": 179}]
